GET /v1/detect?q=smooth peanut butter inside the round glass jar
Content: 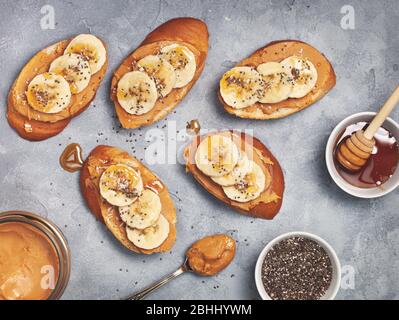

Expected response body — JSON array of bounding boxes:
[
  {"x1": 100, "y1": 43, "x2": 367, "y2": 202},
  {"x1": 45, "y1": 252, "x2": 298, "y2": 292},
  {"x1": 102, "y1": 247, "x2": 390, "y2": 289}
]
[{"x1": 0, "y1": 222, "x2": 59, "y2": 300}]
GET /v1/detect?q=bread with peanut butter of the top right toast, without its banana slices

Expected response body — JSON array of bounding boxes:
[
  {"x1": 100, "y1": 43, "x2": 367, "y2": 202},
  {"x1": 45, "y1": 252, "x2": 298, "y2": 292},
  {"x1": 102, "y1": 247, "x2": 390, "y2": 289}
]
[{"x1": 218, "y1": 40, "x2": 335, "y2": 120}]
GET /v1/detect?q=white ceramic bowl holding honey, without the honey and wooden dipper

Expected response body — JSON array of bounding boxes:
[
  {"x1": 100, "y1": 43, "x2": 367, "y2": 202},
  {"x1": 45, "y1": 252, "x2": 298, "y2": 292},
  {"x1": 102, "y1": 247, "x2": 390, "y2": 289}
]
[{"x1": 326, "y1": 112, "x2": 399, "y2": 198}]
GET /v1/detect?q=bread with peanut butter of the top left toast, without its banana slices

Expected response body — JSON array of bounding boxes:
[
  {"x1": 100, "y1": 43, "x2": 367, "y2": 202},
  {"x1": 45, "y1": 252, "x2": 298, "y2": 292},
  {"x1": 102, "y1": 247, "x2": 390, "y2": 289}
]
[{"x1": 7, "y1": 38, "x2": 108, "y2": 141}]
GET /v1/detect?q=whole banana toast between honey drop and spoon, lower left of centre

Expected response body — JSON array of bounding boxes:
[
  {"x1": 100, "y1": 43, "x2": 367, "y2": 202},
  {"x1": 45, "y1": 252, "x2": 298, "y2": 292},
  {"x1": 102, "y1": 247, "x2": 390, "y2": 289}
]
[{"x1": 80, "y1": 146, "x2": 176, "y2": 254}]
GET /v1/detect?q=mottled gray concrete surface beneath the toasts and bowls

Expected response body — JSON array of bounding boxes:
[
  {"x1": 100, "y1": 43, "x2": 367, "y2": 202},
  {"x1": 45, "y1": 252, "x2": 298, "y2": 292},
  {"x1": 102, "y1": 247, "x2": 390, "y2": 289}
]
[{"x1": 0, "y1": 0, "x2": 399, "y2": 299}]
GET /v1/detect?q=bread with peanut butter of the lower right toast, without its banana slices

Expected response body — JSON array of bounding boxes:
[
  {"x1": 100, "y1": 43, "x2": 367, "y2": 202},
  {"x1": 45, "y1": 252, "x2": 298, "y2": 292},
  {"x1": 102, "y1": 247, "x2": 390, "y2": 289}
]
[{"x1": 184, "y1": 131, "x2": 284, "y2": 219}]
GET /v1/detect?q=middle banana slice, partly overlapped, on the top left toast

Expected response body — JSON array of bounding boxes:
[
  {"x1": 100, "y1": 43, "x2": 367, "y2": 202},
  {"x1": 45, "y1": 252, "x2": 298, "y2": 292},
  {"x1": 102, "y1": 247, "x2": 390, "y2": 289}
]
[{"x1": 49, "y1": 53, "x2": 91, "y2": 94}]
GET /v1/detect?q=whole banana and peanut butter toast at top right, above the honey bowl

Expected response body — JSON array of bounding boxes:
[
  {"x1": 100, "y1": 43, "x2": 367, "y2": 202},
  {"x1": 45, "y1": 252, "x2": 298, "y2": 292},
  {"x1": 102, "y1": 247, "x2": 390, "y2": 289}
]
[{"x1": 219, "y1": 40, "x2": 335, "y2": 120}]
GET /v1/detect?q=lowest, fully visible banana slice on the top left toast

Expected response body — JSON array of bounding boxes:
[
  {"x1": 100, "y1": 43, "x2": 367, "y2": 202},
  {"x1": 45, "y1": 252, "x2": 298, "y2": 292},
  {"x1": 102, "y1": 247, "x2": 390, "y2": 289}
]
[{"x1": 26, "y1": 72, "x2": 71, "y2": 113}]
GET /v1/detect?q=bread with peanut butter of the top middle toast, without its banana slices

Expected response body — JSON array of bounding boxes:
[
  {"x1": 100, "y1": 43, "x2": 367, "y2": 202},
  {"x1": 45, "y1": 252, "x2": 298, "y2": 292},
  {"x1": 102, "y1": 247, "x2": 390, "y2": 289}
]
[{"x1": 111, "y1": 18, "x2": 208, "y2": 128}]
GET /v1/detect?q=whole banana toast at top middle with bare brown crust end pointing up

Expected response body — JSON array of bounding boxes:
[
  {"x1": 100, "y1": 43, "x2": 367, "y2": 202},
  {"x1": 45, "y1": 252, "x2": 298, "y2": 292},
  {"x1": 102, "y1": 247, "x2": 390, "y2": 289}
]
[{"x1": 111, "y1": 18, "x2": 208, "y2": 128}]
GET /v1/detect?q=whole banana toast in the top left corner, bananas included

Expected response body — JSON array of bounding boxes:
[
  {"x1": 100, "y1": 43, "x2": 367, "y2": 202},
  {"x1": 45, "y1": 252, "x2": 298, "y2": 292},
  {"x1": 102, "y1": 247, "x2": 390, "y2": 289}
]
[{"x1": 7, "y1": 34, "x2": 108, "y2": 141}]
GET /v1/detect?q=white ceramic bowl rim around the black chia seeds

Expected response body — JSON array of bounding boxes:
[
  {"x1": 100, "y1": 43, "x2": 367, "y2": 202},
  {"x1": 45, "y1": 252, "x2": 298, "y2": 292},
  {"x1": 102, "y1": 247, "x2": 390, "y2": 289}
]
[{"x1": 255, "y1": 231, "x2": 341, "y2": 300}]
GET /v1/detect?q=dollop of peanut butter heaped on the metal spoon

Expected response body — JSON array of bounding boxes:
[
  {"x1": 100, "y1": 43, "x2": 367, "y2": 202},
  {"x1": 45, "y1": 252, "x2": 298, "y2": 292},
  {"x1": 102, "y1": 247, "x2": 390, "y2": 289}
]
[{"x1": 186, "y1": 234, "x2": 236, "y2": 276}]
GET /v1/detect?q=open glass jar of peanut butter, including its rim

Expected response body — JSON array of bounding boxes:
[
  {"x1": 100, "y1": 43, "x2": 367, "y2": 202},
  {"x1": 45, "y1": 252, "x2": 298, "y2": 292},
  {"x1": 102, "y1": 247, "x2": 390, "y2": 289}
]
[{"x1": 0, "y1": 211, "x2": 71, "y2": 300}]
